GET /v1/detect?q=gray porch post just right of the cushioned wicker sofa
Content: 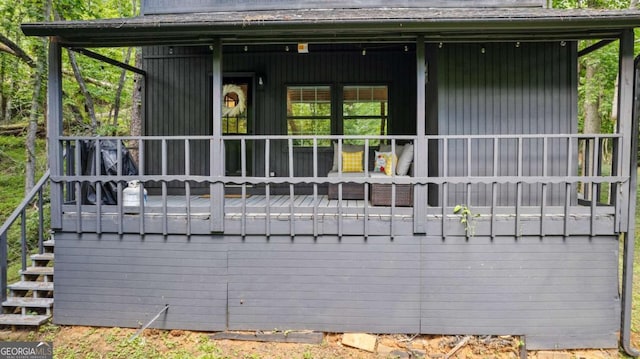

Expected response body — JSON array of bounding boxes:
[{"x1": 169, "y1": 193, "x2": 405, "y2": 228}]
[{"x1": 413, "y1": 36, "x2": 428, "y2": 234}]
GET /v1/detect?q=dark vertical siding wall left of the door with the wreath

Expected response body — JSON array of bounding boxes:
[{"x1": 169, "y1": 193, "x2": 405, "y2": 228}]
[{"x1": 143, "y1": 47, "x2": 212, "y2": 188}]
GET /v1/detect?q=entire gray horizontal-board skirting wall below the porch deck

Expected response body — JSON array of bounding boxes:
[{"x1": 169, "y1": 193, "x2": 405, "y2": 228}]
[{"x1": 54, "y1": 233, "x2": 620, "y2": 349}]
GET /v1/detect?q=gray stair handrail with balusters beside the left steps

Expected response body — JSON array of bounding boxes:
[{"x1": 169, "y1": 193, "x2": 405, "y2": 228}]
[{"x1": 0, "y1": 170, "x2": 50, "y2": 301}]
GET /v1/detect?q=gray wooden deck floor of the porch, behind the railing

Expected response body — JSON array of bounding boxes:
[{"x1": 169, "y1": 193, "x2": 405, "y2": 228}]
[{"x1": 64, "y1": 195, "x2": 616, "y2": 237}]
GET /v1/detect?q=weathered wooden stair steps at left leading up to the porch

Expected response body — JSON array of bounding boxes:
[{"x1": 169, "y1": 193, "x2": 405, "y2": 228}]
[{"x1": 0, "y1": 239, "x2": 55, "y2": 326}]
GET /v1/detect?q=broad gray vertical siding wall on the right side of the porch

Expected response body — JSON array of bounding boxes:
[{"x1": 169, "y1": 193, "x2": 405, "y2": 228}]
[{"x1": 432, "y1": 42, "x2": 577, "y2": 206}]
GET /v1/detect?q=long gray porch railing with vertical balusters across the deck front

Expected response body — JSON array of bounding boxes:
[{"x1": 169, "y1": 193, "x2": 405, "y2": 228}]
[{"x1": 52, "y1": 134, "x2": 628, "y2": 236}]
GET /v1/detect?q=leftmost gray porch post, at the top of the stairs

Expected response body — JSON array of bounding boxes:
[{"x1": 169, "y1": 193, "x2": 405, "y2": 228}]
[{"x1": 47, "y1": 37, "x2": 63, "y2": 229}]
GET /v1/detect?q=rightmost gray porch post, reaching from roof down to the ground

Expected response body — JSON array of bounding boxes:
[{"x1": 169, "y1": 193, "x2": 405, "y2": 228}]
[{"x1": 616, "y1": 30, "x2": 640, "y2": 357}]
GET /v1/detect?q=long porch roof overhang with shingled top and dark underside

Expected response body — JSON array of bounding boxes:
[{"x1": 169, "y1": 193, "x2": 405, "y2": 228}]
[{"x1": 22, "y1": 8, "x2": 640, "y2": 47}]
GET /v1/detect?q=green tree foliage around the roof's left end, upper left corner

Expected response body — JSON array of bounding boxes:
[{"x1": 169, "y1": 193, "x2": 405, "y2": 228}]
[{"x1": 0, "y1": 0, "x2": 139, "y2": 138}]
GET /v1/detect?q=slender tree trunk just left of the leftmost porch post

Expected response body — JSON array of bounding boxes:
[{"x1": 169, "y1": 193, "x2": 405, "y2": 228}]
[{"x1": 24, "y1": 0, "x2": 51, "y2": 194}]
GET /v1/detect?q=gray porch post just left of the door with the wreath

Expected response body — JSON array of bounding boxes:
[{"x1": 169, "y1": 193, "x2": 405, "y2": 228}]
[{"x1": 209, "y1": 39, "x2": 224, "y2": 233}]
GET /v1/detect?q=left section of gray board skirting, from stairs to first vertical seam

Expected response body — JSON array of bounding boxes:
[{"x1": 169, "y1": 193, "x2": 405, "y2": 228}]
[{"x1": 53, "y1": 233, "x2": 227, "y2": 330}]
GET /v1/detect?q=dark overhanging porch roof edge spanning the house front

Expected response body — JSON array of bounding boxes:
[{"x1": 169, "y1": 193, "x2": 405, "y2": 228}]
[{"x1": 22, "y1": 9, "x2": 640, "y2": 46}]
